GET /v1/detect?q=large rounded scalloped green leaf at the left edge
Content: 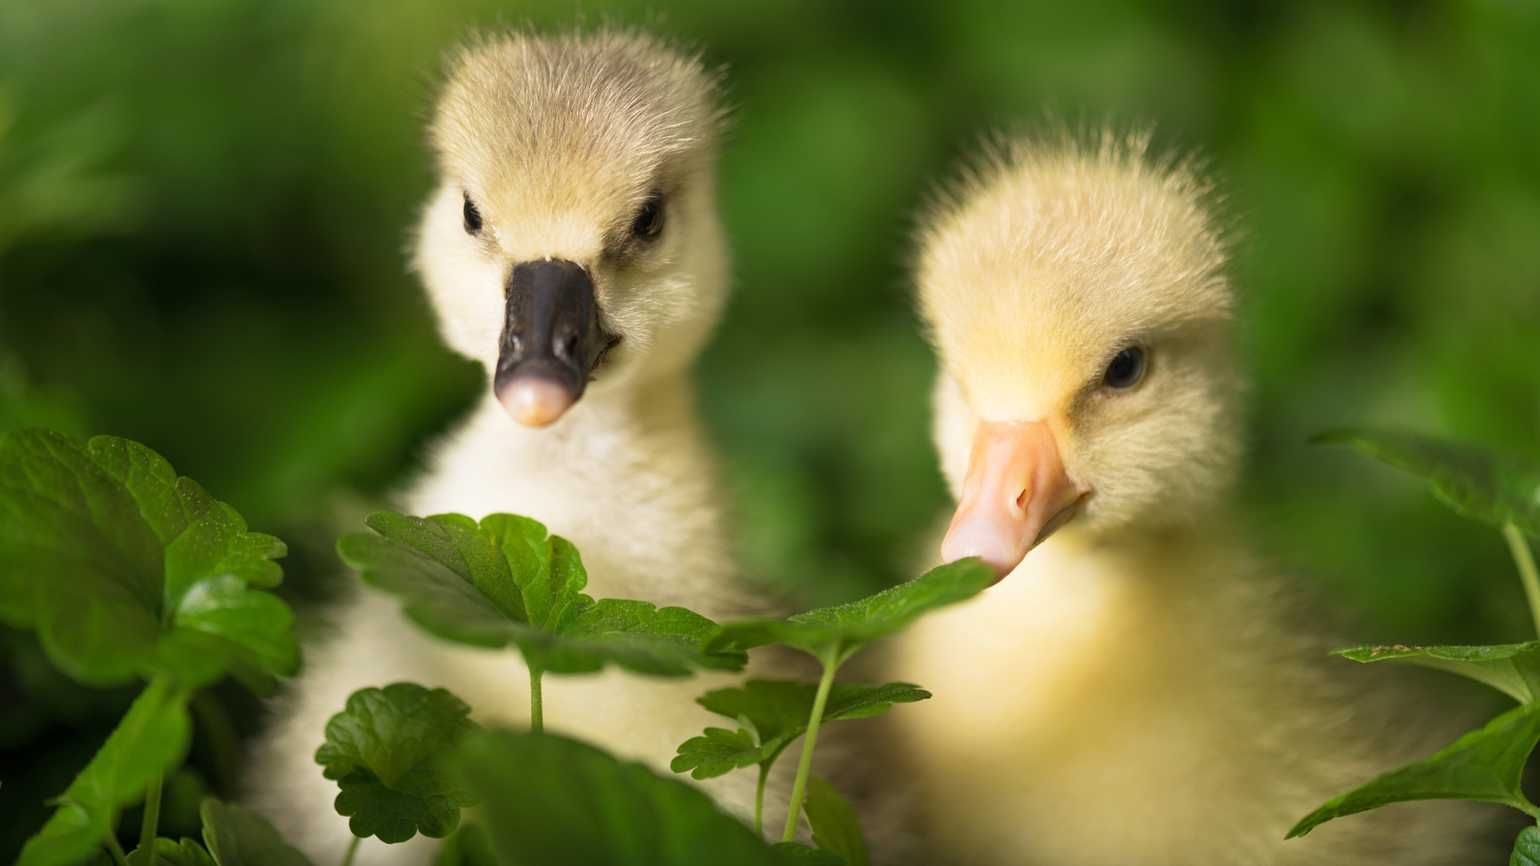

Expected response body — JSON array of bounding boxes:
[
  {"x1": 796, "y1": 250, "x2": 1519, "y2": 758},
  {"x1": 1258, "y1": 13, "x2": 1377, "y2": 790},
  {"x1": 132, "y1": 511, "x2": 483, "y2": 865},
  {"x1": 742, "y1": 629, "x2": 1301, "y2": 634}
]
[{"x1": 0, "y1": 430, "x2": 299, "y2": 687}]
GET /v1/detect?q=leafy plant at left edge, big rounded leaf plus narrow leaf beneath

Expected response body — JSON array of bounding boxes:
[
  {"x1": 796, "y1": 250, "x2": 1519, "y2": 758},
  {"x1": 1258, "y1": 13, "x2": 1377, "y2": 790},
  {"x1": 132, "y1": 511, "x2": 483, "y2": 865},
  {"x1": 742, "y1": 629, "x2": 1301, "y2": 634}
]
[{"x1": 0, "y1": 430, "x2": 299, "y2": 866}]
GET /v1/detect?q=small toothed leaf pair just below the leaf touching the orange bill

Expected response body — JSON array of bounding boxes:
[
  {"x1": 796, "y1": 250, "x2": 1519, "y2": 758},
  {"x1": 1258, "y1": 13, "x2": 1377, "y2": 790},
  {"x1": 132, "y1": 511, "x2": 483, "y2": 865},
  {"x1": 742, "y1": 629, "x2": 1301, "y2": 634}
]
[{"x1": 668, "y1": 680, "x2": 930, "y2": 780}]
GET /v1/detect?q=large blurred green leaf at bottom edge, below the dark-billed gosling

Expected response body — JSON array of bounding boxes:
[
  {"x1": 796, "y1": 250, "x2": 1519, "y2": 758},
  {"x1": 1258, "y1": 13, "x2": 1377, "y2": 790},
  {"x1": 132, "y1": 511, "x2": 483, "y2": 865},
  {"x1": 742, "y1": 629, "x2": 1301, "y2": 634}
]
[{"x1": 456, "y1": 730, "x2": 798, "y2": 866}]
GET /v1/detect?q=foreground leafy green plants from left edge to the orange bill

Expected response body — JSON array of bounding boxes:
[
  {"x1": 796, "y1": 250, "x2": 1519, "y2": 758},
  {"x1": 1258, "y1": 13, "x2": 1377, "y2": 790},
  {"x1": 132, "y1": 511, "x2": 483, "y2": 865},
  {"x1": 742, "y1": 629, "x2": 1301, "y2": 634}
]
[{"x1": 0, "y1": 430, "x2": 993, "y2": 866}]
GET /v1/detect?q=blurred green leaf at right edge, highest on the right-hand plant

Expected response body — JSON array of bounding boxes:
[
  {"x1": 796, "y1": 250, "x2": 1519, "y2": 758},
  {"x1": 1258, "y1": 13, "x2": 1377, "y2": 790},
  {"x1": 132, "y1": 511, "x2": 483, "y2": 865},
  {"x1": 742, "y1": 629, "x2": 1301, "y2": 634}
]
[{"x1": 1314, "y1": 428, "x2": 1540, "y2": 538}]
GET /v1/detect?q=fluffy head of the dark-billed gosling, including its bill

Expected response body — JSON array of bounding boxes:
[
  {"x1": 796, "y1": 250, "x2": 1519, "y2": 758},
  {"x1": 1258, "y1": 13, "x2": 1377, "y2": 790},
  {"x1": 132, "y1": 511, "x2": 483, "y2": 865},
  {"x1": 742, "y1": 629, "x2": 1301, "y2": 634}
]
[{"x1": 416, "y1": 32, "x2": 727, "y2": 427}]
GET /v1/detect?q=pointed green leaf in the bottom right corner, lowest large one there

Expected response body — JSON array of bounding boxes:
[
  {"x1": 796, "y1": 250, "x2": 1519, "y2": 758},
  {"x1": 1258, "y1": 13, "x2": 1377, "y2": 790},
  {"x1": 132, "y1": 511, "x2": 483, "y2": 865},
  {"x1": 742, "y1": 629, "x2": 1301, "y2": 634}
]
[{"x1": 1287, "y1": 704, "x2": 1540, "y2": 838}]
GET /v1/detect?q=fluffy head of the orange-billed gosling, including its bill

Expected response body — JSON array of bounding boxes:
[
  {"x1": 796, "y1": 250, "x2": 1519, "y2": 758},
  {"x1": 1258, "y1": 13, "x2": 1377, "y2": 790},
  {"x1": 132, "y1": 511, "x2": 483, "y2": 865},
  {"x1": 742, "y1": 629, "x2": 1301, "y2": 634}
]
[{"x1": 916, "y1": 137, "x2": 1238, "y2": 575}]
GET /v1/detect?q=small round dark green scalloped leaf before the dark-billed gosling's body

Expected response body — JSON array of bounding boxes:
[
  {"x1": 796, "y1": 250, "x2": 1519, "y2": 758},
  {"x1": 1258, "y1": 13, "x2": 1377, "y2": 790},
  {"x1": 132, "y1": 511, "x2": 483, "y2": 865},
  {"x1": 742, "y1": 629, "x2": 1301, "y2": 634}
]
[{"x1": 316, "y1": 683, "x2": 477, "y2": 843}]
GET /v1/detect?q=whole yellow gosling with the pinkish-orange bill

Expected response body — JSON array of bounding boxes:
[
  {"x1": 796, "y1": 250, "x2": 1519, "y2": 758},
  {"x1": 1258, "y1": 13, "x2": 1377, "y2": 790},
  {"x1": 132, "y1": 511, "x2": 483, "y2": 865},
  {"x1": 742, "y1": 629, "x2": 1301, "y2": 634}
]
[{"x1": 890, "y1": 136, "x2": 1495, "y2": 866}]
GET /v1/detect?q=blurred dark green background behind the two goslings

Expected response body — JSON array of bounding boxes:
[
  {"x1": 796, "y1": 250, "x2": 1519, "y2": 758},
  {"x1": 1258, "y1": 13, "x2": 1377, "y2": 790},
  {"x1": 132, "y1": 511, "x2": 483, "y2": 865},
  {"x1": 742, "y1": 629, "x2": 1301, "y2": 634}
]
[{"x1": 0, "y1": 0, "x2": 1540, "y2": 854}]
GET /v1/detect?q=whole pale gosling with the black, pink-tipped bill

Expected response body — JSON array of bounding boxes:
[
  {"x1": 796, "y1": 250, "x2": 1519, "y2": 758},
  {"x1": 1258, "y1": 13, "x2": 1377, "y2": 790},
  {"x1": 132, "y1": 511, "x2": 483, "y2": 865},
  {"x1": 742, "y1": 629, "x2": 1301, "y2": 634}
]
[{"x1": 253, "y1": 32, "x2": 776, "y2": 863}]
